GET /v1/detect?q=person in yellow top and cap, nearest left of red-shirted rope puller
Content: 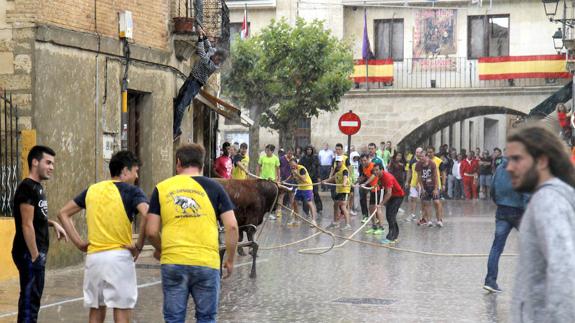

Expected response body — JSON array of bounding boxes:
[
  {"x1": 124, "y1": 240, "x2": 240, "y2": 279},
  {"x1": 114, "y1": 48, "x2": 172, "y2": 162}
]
[{"x1": 322, "y1": 154, "x2": 351, "y2": 230}]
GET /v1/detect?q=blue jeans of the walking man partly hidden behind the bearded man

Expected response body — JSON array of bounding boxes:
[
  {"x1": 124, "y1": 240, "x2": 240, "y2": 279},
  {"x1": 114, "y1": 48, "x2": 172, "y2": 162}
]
[{"x1": 485, "y1": 206, "x2": 523, "y2": 286}]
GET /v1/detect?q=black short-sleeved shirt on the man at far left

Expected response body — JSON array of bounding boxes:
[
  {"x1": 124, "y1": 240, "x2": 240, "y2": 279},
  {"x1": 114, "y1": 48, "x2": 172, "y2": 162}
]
[{"x1": 12, "y1": 178, "x2": 50, "y2": 254}]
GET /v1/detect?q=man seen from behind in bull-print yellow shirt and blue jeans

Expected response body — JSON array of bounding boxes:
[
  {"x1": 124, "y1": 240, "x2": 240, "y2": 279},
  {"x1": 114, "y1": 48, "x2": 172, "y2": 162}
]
[{"x1": 146, "y1": 144, "x2": 238, "y2": 323}]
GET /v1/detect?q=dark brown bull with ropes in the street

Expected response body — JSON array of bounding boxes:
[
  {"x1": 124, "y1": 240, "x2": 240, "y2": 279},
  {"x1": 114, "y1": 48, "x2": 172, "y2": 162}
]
[{"x1": 217, "y1": 179, "x2": 285, "y2": 278}]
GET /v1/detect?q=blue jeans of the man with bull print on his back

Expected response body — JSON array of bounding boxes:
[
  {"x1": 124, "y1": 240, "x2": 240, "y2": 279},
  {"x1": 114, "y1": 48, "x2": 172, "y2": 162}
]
[{"x1": 162, "y1": 265, "x2": 220, "y2": 323}]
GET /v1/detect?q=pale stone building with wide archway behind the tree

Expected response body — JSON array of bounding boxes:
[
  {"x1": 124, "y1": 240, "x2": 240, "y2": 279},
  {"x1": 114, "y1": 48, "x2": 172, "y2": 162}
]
[{"x1": 222, "y1": 0, "x2": 569, "y2": 150}]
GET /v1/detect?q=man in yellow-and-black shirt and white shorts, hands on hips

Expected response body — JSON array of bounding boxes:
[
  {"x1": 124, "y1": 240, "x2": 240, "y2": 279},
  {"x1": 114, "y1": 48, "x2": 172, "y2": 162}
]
[{"x1": 58, "y1": 151, "x2": 148, "y2": 323}]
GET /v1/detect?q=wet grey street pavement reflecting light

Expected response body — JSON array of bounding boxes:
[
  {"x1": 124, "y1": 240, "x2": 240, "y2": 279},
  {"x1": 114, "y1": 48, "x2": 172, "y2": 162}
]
[{"x1": 0, "y1": 194, "x2": 517, "y2": 322}]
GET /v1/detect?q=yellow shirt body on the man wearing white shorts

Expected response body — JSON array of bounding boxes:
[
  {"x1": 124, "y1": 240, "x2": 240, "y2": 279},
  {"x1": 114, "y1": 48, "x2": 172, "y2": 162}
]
[{"x1": 86, "y1": 181, "x2": 132, "y2": 254}]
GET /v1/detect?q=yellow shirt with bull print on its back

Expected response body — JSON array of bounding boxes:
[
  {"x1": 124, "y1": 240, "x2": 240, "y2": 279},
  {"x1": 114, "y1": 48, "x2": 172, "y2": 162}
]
[{"x1": 154, "y1": 175, "x2": 220, "y2": 269}]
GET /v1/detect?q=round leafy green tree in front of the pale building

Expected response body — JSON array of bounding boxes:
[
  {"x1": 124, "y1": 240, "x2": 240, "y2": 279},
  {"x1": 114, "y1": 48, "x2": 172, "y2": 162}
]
[{"x1": 224, "y1": 19, "x2": 353, "y2": 170}]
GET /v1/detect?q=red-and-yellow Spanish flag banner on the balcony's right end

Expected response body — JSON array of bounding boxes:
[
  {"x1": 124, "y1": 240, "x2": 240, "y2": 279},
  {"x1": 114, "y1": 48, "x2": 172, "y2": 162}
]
[{"x1": 479, "y1": 55, "x2": 571, "y2": 81}]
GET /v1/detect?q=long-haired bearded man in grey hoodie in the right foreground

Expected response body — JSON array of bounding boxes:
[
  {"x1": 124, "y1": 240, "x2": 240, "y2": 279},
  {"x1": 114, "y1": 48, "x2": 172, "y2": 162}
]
[{"x1": 507, "y1": 126, "x2": 575, "y2": 322}]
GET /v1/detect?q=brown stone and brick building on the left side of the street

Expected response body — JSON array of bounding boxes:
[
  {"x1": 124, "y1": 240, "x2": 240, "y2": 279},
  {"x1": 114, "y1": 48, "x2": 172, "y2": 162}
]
[{"x1": 0, "y1": 0, "x2": 234, "y2": 274}]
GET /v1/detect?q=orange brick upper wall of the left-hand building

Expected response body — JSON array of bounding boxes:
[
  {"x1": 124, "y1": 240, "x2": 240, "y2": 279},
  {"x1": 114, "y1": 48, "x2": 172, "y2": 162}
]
[{"x1": 8, "y1": 0, "x2": 174, "y2": 49}]
